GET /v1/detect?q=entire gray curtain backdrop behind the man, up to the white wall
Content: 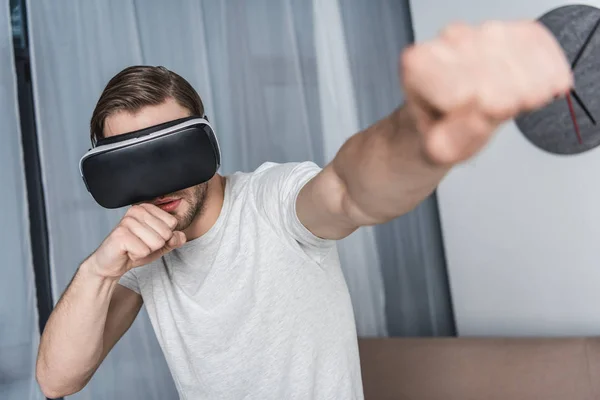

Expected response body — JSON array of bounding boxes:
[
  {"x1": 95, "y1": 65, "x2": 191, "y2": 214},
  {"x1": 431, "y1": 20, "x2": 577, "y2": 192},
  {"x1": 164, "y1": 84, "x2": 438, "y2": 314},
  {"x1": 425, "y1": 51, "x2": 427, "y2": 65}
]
[{"x1": 0, "y1": 0, "x2": 456, "y2": 400}]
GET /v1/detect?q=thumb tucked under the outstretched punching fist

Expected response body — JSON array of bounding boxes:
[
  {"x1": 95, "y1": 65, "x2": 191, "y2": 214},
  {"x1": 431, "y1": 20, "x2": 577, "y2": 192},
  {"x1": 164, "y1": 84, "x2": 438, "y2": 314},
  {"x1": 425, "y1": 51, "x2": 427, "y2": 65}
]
[{"x1": 424, "y1": 108, "x2": 497, "y2": 165}]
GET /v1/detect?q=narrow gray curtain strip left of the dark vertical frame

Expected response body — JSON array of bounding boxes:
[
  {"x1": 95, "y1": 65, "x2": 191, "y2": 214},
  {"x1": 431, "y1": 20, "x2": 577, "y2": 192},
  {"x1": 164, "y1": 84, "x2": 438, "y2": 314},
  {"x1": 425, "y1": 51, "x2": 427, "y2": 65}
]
[{"x1": 0, "y1": 2, "x2": 44, "y2": 400}]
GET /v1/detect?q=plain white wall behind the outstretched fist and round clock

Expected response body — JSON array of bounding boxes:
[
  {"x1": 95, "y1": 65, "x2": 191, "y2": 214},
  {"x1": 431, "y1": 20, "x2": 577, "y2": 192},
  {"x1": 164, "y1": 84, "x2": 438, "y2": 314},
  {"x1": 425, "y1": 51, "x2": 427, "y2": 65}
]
[{"x1": 411, "y1": 0, "x2": 600, "y2": 336}]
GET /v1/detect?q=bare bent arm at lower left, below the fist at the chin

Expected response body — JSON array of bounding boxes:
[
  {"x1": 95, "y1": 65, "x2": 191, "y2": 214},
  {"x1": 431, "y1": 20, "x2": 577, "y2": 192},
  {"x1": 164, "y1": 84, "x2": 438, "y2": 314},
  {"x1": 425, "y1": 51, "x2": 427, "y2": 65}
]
[{"x1": 36, "y1": 261, "x2": 142, "y2": 398}]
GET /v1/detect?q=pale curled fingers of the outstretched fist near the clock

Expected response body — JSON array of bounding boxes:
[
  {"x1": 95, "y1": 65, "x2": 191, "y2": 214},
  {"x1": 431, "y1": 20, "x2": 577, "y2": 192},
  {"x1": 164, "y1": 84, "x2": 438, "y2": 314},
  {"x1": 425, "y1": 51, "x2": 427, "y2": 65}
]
[{"x1": 402, "y1": 21, "x2": 573, "y2": 121}]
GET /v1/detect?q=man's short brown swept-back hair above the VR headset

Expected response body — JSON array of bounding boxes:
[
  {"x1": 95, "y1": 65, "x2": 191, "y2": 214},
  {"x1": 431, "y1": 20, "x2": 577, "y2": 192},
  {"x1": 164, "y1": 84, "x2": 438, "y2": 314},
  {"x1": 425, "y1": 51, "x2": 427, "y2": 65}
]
[{"x1": 90, "y1": 65, "x2": 204, "y2": 144}]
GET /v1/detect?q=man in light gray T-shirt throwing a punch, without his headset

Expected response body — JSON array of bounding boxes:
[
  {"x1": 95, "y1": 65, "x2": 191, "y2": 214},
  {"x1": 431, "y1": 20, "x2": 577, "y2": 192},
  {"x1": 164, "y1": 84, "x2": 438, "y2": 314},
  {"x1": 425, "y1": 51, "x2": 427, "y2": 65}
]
[{"x1": 37, "y1": 21, "x2": 573, "y2": 399}]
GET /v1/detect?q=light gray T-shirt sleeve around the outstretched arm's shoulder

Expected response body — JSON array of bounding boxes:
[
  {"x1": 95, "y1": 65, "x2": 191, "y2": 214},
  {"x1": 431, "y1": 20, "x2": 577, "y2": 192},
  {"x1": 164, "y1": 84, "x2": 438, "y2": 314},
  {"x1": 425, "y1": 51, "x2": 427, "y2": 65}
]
[{"x1": 253, "y1": 162, "x2": 335, "y2": 249}]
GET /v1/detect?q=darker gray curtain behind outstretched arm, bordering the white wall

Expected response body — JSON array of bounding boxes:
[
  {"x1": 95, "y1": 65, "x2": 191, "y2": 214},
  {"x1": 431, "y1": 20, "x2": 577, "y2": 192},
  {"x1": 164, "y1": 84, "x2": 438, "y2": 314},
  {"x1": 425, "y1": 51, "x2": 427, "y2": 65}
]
[{"x1": 340, "y1": 0, "x2": 455, "y2": 336}]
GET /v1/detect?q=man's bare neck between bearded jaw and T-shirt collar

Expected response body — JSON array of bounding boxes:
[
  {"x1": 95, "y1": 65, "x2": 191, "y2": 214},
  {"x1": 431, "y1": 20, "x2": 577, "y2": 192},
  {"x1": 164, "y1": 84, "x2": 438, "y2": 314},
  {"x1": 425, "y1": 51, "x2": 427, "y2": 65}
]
[{"x1": 183, "y1": 174, "x2": 225, "y2": 241}]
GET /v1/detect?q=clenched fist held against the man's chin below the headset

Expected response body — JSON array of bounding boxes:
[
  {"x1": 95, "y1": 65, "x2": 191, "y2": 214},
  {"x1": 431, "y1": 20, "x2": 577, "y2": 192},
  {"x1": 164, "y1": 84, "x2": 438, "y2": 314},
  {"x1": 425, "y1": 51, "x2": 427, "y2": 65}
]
[{"x1": 89, "y1": 204, "x2": 186, "y2": 279}]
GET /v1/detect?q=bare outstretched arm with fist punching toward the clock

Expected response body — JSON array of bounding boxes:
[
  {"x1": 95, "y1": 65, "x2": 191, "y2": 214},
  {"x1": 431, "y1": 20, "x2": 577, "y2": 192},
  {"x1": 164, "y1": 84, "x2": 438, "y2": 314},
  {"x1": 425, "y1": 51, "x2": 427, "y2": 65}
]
[{"x1": 296, "y1": 22, "x2": 573, "y2": 239}]
